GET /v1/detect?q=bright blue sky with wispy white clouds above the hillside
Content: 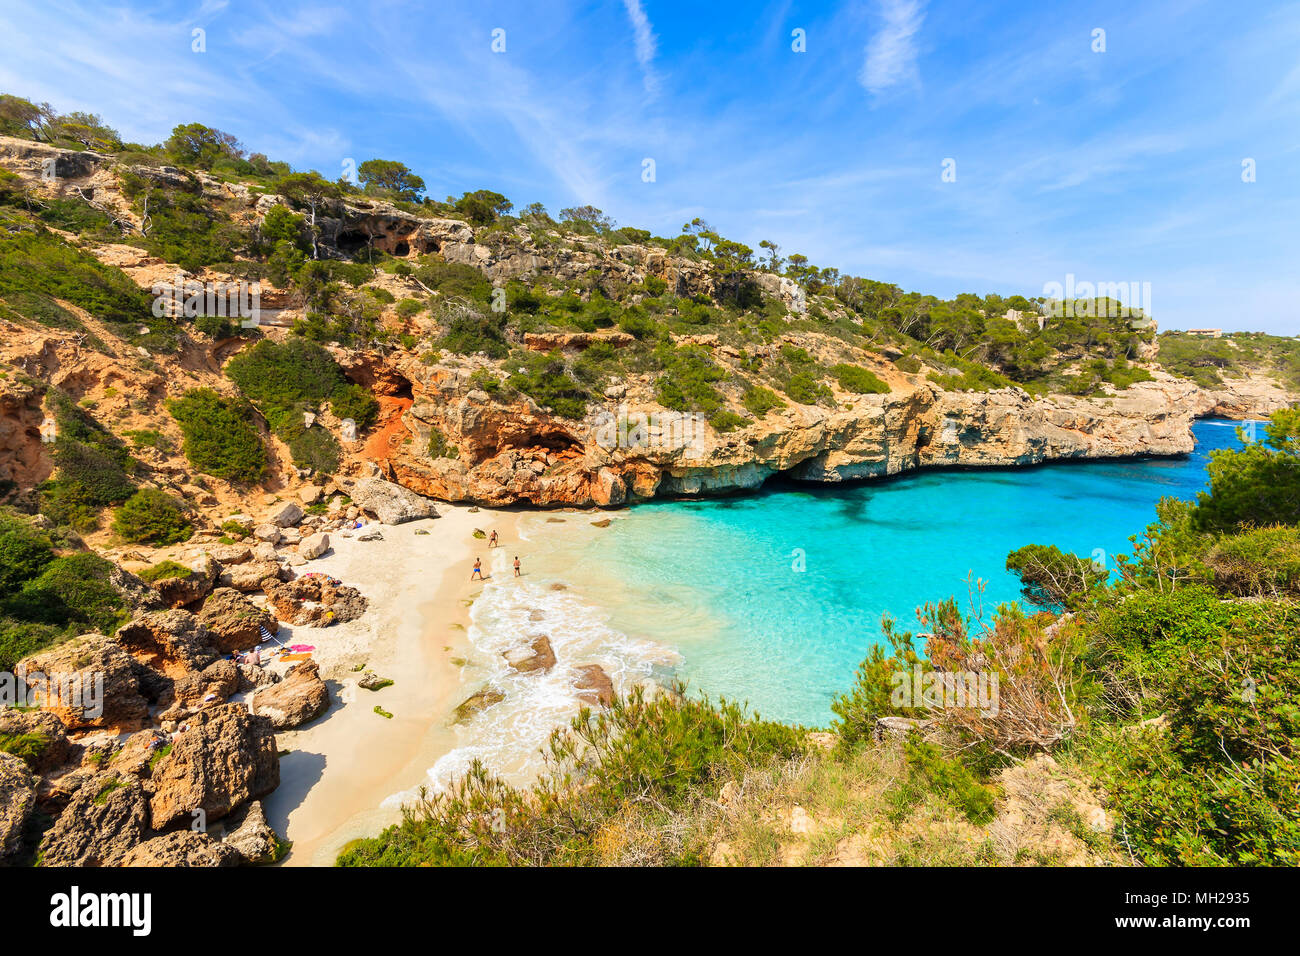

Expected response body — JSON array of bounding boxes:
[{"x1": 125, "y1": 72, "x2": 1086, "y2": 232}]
[{"x1": 0, "y1": 0, "x2": 1300, "y2": 334}]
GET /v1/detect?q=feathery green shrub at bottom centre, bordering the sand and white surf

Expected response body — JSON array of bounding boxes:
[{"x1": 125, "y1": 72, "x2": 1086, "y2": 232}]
[{"x1": 338, "y1": 691, "x2": 805, "y2": 866}]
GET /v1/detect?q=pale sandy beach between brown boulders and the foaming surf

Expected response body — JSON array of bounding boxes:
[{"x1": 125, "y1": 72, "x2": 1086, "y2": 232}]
[{"x1": 265, "y1": 505, "x2": 527, "y2": 866}]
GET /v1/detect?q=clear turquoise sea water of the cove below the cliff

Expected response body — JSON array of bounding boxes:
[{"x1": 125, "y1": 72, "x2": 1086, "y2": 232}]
[{"x1": 529, "y1": 420, "x2": 1240, "y2": 724}]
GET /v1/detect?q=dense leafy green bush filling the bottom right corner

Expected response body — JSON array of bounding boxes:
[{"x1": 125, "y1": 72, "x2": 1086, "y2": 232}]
[{"x1": 1095, "y1": 621, "x2": 1300, "y2": 866}]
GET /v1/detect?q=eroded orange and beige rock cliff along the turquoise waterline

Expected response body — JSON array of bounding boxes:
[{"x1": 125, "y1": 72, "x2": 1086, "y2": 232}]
[{"x1": 366, "y1": 362, "x2": 1294, "y2": 507}]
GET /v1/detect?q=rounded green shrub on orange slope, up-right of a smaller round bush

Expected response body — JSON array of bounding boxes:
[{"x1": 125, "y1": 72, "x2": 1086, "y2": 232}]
[{"x1": 166, "y1": 389, "x2": 267, "y2": 484}]
